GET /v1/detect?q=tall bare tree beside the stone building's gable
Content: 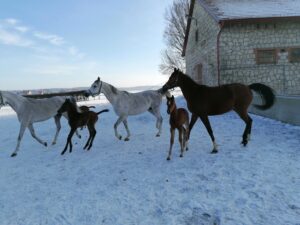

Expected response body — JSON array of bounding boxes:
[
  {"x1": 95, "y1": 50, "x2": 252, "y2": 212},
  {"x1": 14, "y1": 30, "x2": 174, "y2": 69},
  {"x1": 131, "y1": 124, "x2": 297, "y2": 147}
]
[{"x1": 159, "y1": 0, "x2": 190, "y2": 74}]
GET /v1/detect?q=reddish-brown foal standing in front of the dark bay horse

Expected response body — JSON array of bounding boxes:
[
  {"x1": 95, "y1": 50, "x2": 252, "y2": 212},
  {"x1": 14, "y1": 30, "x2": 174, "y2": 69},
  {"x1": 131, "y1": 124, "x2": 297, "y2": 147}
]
[{"x1": 167, "y1": 95, "x2": 189, "y2": 160}]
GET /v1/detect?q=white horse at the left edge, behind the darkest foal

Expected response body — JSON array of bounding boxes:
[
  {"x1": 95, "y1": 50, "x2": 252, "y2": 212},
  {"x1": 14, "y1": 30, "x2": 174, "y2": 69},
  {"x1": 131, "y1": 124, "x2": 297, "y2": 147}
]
[{"x1": 0, "y1": 91, "x2": 80, "y2": 157}]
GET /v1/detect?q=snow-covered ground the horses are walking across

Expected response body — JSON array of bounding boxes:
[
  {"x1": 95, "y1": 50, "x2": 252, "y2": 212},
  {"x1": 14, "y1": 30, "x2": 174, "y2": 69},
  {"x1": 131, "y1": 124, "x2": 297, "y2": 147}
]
[{"x1": 0, "y1": 92, "x2": 300, "y2": 225}]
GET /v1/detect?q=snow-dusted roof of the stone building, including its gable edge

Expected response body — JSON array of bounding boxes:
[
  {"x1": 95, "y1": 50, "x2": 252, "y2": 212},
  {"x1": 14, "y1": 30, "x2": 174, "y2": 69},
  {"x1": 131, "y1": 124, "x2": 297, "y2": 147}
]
[{"x1": 182, "y1": 0, "x2": 300, "y2": 56}]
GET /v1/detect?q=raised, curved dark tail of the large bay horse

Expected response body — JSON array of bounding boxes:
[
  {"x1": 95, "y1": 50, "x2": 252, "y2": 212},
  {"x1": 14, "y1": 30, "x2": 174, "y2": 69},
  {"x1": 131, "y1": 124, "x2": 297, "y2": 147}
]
[{"x1": 248, "y1": 83, "x2": 275, "y2": 110}]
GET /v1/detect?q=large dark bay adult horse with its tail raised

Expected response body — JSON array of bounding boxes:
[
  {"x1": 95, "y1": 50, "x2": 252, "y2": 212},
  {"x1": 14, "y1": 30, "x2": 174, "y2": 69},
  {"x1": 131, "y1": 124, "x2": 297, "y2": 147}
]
[{"x1": 162, "y1": 69, "x2": 275, "y2": 153}]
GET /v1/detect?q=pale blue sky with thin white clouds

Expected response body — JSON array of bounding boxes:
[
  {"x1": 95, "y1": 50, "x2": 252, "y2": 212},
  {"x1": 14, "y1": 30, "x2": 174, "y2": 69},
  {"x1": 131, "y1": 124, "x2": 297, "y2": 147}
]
[{"x1": 0, "y1": 0, "x2": 172, "y2": 90}]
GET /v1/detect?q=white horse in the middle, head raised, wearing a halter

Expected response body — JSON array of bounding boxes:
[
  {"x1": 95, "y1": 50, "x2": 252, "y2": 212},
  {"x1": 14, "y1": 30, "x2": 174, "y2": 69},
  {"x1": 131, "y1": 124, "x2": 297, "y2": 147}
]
[{"x1": 86, "y1": 77, "x2": 168, "y2": 141}]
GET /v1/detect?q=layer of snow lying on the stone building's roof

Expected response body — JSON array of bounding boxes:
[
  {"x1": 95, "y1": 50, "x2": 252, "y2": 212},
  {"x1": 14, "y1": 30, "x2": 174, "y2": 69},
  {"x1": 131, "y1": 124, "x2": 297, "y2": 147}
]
[{"x1": 199, "y1": 0, "x2": 300, "y2": 20}]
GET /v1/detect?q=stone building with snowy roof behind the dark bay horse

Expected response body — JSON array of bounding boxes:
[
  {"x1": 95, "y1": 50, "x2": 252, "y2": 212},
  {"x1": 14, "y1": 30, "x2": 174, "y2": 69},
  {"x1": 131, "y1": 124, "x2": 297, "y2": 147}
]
[{"x1": 182, "y1": 0, "x2": 300, "y2": 124}]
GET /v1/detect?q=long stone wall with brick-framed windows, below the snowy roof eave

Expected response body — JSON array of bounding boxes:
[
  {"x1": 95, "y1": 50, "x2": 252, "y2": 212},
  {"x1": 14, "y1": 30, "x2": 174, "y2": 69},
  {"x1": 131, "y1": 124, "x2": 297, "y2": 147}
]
[{"x1": 220, "y1": 22, "x2": 300, "y2": 95}]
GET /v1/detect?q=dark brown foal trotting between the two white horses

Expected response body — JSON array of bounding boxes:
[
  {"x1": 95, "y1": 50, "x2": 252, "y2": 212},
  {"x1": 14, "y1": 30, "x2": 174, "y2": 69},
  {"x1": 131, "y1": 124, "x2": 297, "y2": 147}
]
[{"x1": 57, "y1": 99, "x2": 109, "y2": 155}]
